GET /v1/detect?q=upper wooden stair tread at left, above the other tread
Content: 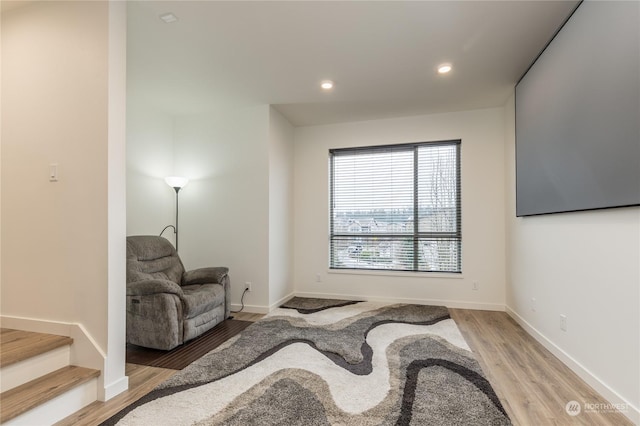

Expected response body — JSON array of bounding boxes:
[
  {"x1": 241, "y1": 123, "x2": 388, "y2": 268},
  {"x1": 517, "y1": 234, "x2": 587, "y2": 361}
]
[{"x1": 0, "y1": 328, "x2": 73, "y2": 367}]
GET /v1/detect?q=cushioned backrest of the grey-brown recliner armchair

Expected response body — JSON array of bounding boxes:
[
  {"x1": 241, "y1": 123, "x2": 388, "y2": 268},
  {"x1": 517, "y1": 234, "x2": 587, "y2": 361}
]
[{"x1": 127, "y1": 235, "x2": 184, "y2": 285}]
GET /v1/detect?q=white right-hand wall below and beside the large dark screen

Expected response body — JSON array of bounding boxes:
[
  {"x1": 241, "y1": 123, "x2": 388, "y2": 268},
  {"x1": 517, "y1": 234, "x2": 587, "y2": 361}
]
[{"x1": 506, "y1": 98, "x2": 640, "y2": 422}]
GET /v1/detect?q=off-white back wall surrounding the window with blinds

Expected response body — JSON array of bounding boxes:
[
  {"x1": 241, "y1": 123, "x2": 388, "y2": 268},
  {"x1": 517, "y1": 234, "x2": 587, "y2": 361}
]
[{"x1": 294, "y1": 108, "x2": 505, "y2": 310}]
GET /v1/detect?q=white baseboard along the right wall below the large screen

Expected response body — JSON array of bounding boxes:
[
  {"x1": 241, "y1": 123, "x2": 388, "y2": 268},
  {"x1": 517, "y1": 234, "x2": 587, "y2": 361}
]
[{"x1": 505, "y1": 306, "x2": 640, "y2": 424}]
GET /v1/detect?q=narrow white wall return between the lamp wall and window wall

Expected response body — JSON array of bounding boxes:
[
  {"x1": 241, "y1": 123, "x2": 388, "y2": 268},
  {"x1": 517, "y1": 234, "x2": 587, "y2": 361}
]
[{"x1": 269, "y1": 107, "x2": 293, "y2": 306}]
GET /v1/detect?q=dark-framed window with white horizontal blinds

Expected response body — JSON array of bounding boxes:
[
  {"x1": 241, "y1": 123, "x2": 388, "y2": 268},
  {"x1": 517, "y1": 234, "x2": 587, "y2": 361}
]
[{"x1": 329, "y1": 140, "x2": 462, "y2": 272}]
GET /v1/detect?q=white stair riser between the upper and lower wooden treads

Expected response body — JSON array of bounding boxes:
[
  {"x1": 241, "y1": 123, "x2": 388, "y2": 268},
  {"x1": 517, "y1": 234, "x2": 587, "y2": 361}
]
[{"x1": 0, "y1": 346, "x2": 71, "y2": 392}]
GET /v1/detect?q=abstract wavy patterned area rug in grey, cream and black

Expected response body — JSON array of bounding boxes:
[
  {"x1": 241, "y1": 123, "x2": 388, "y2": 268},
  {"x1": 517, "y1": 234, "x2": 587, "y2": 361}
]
[{"x1": 103, "y1": 298, "x2": 511, "y2": 426}]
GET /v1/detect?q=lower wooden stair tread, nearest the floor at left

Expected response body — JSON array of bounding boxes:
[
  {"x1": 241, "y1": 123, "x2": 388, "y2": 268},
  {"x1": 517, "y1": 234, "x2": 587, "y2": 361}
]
[{"x1": 0, "y1": 365, "x2": 100, "y2": 423}]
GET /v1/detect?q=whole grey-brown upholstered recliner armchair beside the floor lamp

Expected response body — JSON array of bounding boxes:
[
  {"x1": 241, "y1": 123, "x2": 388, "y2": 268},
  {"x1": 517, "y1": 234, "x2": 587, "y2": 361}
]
[{"x1": 127, "y1": 235, "x2": 231, "y2": 350}]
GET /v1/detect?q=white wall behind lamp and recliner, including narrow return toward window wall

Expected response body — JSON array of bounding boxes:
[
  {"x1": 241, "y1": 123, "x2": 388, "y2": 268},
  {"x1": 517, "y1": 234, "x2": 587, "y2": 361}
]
[{"x1": 127, "y1": 104, "x2": 293, "y2": 312}]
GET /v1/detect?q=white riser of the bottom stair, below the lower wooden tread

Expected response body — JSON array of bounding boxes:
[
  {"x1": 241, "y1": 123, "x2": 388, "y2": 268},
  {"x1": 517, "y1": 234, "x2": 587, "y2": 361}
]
[{"x1": 2, "y1": 378, "x2": 98, "y2": 426}]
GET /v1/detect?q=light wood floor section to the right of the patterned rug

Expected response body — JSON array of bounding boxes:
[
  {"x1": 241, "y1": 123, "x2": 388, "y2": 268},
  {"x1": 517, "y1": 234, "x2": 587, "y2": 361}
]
[{"x1": 449, "y1": 309, "x2": 633, "y2": 426}]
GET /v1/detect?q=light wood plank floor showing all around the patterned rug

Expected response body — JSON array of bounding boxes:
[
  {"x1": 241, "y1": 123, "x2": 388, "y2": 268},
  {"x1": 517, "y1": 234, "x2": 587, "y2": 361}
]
[{"x1": 57, "y1": 309, "x2": 633, "y2": 426}]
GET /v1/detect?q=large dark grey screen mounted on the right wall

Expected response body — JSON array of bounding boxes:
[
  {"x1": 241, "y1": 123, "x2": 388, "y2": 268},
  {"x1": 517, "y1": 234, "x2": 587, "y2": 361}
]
[{"x1": 516, "y1": 1, "x2": 640, "y2": 216}]
